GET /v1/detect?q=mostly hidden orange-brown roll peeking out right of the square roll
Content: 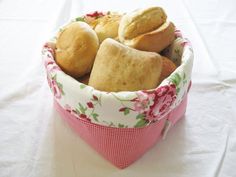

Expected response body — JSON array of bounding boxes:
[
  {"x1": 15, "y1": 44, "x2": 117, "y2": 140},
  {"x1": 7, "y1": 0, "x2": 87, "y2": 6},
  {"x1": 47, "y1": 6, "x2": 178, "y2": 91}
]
[{"x1": 160, "y1": 56, "x2": 176, "y2": 82}]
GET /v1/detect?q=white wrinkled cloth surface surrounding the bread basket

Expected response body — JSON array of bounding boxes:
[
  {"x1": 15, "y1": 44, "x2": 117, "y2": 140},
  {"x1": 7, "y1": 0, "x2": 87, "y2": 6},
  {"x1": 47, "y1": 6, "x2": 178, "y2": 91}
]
[{"x1": 0, "y1": 0, "x2": 236, "y2": 177}]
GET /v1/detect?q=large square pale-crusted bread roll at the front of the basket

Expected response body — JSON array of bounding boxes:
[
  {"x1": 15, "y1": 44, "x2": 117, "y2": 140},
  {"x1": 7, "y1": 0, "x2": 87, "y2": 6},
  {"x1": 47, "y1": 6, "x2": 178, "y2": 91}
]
[{"x1": 89, "y1": 38, "x2": 162, "y2": 92}]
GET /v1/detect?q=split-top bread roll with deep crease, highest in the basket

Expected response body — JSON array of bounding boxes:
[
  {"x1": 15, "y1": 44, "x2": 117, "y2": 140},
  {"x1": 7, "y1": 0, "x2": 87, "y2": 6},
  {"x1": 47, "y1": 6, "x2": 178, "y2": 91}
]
[{"x1": 118, "y1": 7, "x2": 175, "y2": 52}]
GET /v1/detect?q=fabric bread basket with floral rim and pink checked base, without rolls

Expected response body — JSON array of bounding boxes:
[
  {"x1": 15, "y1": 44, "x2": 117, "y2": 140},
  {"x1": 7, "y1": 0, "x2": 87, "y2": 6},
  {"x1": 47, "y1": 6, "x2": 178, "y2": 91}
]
[{"x1": 42, "y1": 15, "x2": 193, "y2": 168}]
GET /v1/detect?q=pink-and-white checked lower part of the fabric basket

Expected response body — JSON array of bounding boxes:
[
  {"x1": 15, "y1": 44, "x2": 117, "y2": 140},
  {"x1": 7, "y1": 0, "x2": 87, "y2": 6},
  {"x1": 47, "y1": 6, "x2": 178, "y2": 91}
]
[{"x1": 54, "y1": 95, "x2": 187, "y2": 169}]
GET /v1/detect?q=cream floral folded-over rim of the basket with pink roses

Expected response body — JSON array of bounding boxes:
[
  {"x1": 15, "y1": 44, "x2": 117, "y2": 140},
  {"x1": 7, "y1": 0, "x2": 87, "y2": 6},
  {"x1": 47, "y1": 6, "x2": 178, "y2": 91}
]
[{"x1": 42, "y1": 13, "x2": 193, "y2": 128}]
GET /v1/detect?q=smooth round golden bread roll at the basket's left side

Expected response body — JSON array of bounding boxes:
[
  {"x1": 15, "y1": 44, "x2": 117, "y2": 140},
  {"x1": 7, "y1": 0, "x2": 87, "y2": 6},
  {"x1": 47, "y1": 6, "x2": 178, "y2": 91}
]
[{"x1": 56, "y1": 22, "x2": 99, "y2": 78}]
